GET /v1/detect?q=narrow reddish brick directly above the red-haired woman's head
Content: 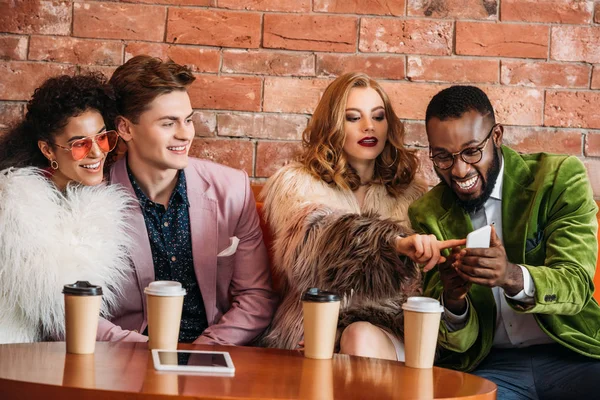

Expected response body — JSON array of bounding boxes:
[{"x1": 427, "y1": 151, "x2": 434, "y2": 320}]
[{"x1": 317, "y1": 53, "x2": 404, "y2": 79}]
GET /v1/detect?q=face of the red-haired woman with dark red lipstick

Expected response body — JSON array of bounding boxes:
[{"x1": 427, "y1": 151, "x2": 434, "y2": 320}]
[{"x1": 343, "y1": 87, "x2": 388, "y2": 167}]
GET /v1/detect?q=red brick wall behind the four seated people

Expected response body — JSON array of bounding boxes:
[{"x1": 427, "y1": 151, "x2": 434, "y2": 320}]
[{"x1": 0, "y1": 0, "x2": 600, "y2": 198}]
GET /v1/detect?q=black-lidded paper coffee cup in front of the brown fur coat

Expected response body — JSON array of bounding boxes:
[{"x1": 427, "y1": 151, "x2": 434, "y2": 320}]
[{"x1": 302, "y1": 288, "x2": 340, "y2": 359}]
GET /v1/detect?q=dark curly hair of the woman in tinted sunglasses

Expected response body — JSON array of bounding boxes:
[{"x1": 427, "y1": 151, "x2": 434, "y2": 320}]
[{"x1": 0, "y1": 72, "x2": 116, "y2": 170}]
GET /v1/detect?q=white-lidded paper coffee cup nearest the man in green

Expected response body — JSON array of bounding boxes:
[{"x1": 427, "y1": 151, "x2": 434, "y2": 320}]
[{"x1": 402, "y1": 297, "x2": 444, "y2": 368}]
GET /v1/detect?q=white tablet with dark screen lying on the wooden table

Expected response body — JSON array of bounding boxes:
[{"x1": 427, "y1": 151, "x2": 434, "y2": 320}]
[{"x1": 152, "y1": 349, "x2": 235, "y2": 375}]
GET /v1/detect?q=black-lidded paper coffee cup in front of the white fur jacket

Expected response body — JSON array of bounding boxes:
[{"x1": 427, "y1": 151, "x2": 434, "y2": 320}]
[{"x1": 63, "y1": 281, "x2": 102, "y2": 354}]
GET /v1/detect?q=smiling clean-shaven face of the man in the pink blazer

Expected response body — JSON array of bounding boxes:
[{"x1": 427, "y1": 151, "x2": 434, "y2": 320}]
[{"x1": 119, "y1": 90, "x2": 195, "y2": 172}]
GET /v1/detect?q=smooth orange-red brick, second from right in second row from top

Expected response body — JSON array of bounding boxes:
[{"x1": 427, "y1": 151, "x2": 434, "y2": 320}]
[{"x1": 456, "y1": 21, "x2": 549, "y2": 58}]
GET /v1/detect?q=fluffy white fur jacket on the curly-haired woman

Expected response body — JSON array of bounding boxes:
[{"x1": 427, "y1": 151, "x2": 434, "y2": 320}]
[{"x1": 0, "y1": 168, "x2": 132, "y2": 343}]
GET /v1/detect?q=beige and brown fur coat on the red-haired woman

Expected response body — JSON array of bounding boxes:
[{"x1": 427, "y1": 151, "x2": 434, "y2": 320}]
[{"x1": 262, "y1": 164, "x2": 426, "y2": 349}]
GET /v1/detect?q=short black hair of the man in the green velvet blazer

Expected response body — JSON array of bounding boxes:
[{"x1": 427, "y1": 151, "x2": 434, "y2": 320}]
[{"x1": 425, "y1": 86, "x2": 496, "y2": 124}]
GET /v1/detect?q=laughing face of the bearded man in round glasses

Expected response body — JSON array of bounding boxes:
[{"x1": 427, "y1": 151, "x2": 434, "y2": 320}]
[{"x1": 427, "y1": 111, "x2": 503, "y2": 212}]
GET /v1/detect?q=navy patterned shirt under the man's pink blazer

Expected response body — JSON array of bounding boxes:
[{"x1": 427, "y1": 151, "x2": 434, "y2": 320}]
[{"x1": 127, "y1": 168, "x2": 208, "y2": 342}]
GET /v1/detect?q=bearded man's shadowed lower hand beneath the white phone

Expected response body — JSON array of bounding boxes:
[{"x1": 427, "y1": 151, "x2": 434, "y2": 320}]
[{"x1": 438, "y1": 246, "x2": 471, "y2": 315}]
